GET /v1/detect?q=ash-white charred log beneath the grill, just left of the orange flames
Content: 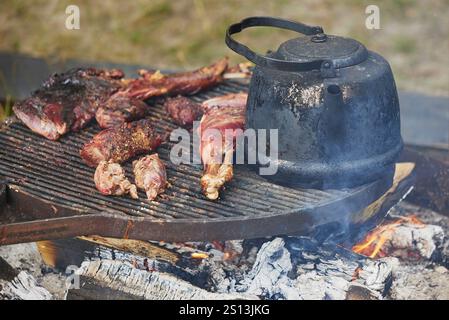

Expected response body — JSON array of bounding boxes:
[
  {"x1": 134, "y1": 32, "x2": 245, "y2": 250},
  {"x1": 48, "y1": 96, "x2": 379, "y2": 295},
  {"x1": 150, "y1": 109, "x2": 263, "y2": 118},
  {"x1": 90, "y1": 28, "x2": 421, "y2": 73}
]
[{"x1": 233, "y1": 238, "x2": 396, "y2": 300}]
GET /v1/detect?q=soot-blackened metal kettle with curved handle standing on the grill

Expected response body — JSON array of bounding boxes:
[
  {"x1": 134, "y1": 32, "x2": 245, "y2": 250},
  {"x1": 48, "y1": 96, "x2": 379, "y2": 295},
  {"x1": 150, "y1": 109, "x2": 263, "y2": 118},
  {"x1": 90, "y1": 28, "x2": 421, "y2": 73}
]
[{"x1": 226, "y1": 17, "x2": 403, "y2": 189}]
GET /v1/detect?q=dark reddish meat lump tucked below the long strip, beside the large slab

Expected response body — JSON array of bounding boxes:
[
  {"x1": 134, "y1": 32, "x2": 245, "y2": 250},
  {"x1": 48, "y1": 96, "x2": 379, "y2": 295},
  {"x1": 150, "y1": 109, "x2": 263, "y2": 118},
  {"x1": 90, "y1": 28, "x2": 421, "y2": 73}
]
[{"x1": 95, "y1": 94, "x2": 148, "y2": 129}]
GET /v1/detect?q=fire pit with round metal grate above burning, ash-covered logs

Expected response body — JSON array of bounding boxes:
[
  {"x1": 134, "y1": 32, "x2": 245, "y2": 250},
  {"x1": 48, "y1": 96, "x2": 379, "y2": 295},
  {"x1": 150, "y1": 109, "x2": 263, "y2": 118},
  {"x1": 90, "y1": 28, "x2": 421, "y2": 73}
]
[{"x1": 0, "y1": 53, "x2": 449, "y2": 299}]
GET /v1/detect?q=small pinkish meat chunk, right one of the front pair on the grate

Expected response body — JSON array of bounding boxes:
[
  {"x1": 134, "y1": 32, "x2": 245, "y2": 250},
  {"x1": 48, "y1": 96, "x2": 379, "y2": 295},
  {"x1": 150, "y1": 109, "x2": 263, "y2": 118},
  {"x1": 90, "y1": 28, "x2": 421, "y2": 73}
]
[{"x1": 133, "y1": 154, "x2": 167, "y2": 200}]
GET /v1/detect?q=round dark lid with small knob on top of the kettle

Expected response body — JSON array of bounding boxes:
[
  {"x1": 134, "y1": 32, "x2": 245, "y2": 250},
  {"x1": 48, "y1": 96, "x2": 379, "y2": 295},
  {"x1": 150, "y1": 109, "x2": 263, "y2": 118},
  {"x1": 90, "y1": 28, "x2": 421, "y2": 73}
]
[{"x1": 276, "y1": 33, "x2": 367, "y2": 68}]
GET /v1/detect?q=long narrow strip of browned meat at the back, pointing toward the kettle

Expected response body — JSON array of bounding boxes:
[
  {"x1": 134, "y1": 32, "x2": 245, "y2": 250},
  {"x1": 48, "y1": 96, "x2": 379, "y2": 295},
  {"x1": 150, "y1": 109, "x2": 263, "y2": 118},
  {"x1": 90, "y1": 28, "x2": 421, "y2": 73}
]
[{"x1": 124, "y1": 58, "x2": 228, "y2": 100}]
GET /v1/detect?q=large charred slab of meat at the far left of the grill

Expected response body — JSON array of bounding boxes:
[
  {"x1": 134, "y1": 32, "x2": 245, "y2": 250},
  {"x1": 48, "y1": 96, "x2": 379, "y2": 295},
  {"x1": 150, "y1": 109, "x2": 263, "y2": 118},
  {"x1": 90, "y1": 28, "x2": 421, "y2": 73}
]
[{"x1": 13, "y1": 68, "x2": 123, "y2": 140}]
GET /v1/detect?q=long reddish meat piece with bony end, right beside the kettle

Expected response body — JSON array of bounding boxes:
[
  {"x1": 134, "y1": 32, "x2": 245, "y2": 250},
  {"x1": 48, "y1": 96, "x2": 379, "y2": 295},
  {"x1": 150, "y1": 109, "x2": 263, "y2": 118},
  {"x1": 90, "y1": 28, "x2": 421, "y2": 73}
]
[{"x1": 198, "y1": 93, "x2": 247, "y2": 200}]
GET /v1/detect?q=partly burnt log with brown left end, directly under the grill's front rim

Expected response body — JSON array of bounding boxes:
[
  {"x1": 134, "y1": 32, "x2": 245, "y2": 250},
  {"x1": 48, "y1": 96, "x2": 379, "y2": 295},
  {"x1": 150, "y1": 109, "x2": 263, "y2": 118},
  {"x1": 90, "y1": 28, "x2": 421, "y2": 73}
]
[{"x1": 37, "y1": 236, "x2": 212, "y2": 287}]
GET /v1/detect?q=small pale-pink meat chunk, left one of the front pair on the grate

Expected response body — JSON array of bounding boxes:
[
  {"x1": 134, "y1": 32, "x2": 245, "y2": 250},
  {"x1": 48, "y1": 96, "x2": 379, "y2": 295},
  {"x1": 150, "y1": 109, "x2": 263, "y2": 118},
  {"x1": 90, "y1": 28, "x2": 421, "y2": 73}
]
[{"x1": 94, "y1": 161, "x2": 139, "y2": 199}]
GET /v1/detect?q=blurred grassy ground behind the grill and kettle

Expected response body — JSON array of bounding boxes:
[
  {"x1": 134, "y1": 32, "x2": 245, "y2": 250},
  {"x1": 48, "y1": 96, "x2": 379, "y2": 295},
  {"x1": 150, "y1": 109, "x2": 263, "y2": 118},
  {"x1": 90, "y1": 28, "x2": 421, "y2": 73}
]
[{"x1": 0, "y1": 0, "x2": 449, "y2": 117}]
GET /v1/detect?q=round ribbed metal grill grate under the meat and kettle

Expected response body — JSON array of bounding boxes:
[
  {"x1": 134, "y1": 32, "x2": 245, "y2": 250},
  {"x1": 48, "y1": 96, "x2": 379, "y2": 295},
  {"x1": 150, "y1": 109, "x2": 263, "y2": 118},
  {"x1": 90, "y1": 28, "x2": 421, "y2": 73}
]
[{"x1": 0, "y1": 81, "x2": 392, "y2": 241}]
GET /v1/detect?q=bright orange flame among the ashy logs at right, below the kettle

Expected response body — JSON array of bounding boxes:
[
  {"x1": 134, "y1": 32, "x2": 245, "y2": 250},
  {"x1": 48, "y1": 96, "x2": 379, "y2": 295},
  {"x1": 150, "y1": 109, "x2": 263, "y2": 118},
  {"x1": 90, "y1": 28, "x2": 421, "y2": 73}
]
[{"x1": 352, "y1": 215, "x2": 424, "y2": 259}]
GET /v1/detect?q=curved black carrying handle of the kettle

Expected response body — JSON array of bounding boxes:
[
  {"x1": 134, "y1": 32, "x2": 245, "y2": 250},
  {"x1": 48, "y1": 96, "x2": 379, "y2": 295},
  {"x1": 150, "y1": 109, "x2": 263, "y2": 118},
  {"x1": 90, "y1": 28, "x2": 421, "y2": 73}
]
[{"x1": 225, "y1": 17, "x2": 332, "y2": 71}]
